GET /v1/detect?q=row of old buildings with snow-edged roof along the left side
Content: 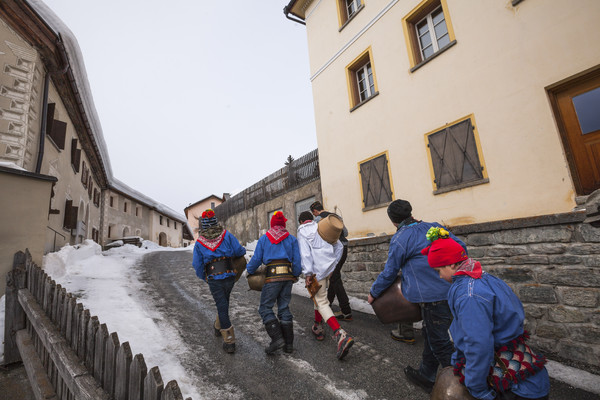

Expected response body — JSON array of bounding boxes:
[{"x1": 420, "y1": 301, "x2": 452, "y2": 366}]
[{"x1": 0, "y1": 0, "x2": 192, "y2": 295}]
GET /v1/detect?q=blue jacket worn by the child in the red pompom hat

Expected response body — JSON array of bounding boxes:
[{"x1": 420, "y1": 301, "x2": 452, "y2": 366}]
[{"x1": 448, "y1": 272, "x2": 550, "y2": 400}]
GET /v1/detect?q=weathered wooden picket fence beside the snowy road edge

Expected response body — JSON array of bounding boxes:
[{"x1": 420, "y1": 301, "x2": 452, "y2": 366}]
[{"x1": 4, "y1": 250, "x2": 191, "y2": 400}]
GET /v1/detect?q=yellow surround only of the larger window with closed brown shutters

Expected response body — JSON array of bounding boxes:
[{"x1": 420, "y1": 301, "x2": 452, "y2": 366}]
[{"x1": 424, "y1": 114, "x2": 490, "y2": 195}]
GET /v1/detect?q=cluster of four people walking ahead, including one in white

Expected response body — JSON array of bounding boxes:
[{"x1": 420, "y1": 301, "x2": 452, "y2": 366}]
[{"x1": 192, "y1": 201, "x2": 354, "y2": 360}]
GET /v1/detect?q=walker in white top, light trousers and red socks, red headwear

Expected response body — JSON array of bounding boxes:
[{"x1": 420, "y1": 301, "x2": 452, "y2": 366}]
[{"x1": 298, "y1": 211, "x2": 354, "y2": 360}]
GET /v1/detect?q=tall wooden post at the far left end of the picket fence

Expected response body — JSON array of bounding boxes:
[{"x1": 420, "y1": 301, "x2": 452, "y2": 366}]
[{"x1": 4, "y1": 251, "x2": 31, "y2": 364}]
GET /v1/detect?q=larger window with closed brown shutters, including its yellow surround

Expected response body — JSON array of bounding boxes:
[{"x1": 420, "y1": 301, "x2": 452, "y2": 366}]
[{"x1": 425, "y1": 116, "x2": 489, "y2": 194}]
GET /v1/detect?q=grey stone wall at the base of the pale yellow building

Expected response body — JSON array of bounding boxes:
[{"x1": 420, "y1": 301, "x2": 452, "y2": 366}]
[{"x1": 342, "y1": 212, "x2": 600, "y2": 373}]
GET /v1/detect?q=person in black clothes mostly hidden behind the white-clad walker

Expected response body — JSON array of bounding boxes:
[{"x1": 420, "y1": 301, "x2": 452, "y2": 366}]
[{"x1": 310, "y1": 201, "x2": 352, "y2": 321}]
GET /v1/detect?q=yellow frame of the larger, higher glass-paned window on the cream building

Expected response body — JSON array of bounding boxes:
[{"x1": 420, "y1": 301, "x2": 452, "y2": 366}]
[{"x1": 402, "y1": 0, "x2": 456, "y2": 72}]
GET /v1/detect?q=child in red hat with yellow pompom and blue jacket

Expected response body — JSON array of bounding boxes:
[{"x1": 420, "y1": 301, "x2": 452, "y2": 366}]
[{"x1": 422, "y1": 228, "x2": 550, "y2": 400}]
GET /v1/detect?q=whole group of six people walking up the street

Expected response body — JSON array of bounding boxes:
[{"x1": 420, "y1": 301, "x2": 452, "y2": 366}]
[{"x1": 193, "y1": 200, "x2": 550, "y2": 400}]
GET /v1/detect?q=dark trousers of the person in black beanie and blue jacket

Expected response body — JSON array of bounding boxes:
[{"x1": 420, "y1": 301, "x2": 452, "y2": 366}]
[{"x1": 419, "y1": 300, "x2": 454, "y2": 382}]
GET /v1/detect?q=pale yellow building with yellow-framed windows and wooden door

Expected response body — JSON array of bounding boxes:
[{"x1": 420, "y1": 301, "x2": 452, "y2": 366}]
[{"x1": 284, "y1": 0, "x2": 600, "y2": 237}]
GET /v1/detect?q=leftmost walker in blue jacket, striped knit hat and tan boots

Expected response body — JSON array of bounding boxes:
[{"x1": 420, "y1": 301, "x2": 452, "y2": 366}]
[{"x1": 192, "y1": 209, "x2": 246, "y2": 353}]
